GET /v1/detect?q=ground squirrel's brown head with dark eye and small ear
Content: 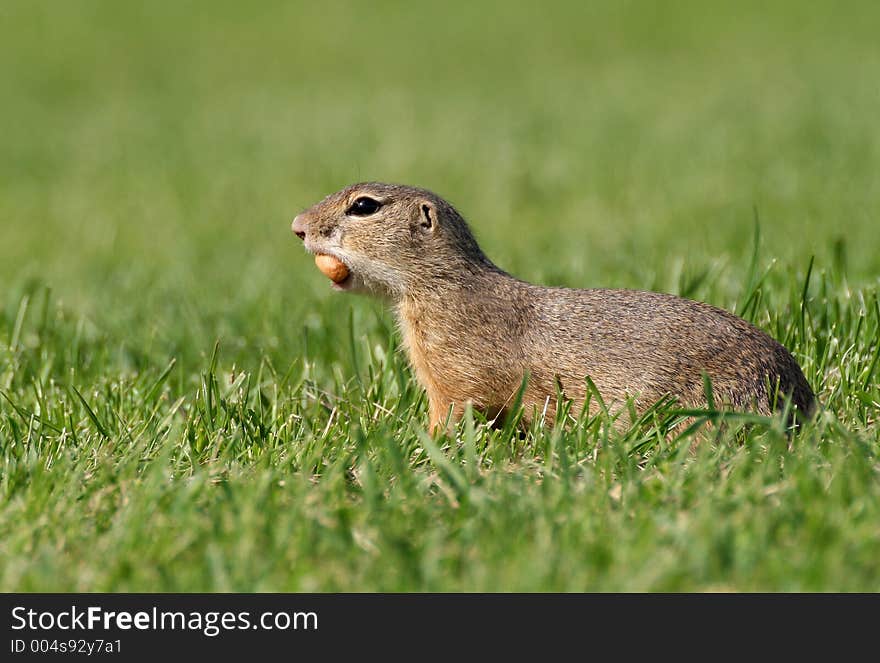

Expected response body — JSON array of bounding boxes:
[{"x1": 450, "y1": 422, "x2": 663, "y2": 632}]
[{"x1": 292, "y1": 182, "x2": 491, "y2": 299}]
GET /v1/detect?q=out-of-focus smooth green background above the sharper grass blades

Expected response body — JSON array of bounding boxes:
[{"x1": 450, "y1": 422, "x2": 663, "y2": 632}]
[{"x1": 0, "y1": 0, "x2": 880, "y2": 316}]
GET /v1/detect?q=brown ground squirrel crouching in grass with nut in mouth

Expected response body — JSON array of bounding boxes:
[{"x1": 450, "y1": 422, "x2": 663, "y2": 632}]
[{"x1": 292, "y1": 182, "x2": 814, "y2": 430}]
